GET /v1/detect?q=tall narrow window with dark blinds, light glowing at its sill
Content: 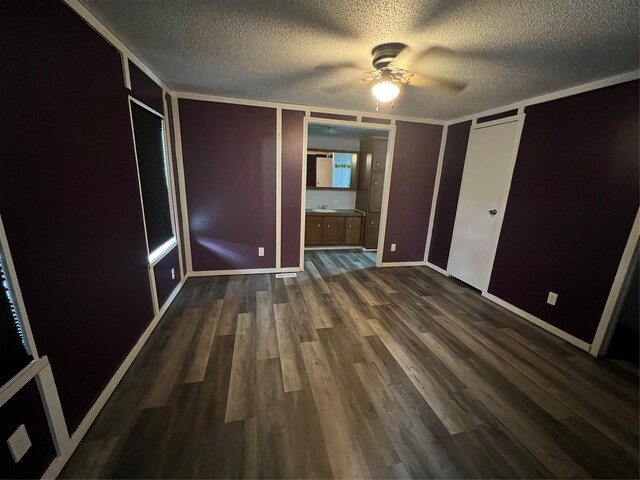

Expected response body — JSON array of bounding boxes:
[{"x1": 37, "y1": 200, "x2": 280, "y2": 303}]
[{"x1": 130, "y1": 99, "x2": 175, "y2": 263}]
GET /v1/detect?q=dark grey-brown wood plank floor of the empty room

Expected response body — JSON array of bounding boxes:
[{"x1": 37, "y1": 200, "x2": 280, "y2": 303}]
[{"x1": 62, "y1": 252, "x2": 639, "y2": 478}]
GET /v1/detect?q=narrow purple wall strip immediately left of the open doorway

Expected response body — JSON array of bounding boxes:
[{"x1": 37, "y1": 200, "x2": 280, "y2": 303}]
[{"x1": 280, "y1": 110, "x2": 304, "y2": 268}]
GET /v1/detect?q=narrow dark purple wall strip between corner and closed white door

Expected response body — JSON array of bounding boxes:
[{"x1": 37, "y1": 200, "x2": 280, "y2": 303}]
[{"x1": 428, "y1": 121, "x2": 471, "y2": 270}]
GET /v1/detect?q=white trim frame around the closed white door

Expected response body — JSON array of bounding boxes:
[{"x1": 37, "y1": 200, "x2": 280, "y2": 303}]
[{"x1": 447, "y1": 112, "x2": 526, "y2": 294}]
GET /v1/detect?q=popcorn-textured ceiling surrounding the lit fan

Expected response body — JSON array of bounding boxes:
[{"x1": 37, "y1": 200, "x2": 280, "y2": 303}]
[{"x1": 81, "y1": 0, "x2": 639, "y2": 120}]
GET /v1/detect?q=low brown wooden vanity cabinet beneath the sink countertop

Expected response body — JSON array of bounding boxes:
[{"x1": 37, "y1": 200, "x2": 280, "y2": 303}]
[{"x1": 304, "y1": 215, "x2": 362, "y2": 247}]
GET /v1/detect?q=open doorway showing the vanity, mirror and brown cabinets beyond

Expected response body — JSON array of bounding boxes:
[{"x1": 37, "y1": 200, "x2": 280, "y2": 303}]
[{"x1": 301, "y1": 118, "x2": 394, "y2": 265}]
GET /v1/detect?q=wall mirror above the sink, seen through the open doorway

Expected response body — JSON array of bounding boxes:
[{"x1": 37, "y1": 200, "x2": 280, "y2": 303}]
[{"x1": 307, "y1": 150, "x2": 358, "y2": 190}]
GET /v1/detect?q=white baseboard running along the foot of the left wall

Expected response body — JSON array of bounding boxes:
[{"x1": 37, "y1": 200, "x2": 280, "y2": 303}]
[{"x1": 42, "y1": 278, "x2": 186, "y2": 479}]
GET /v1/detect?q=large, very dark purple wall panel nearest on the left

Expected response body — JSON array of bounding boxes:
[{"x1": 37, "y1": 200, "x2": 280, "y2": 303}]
[{"x1": 0, "y1": 2, "x2": 153, "y2": 432}]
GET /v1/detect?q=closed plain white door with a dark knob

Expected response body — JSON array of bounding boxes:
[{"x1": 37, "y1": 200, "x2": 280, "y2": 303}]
[{"x1": 447, "y1": 114, "x2": 524, "y2": 291}]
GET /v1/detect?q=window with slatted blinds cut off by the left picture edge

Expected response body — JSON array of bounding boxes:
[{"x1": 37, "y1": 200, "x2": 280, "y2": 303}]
[{"x1": 0, "y1": 252, "x2": 32, "y2": 386}]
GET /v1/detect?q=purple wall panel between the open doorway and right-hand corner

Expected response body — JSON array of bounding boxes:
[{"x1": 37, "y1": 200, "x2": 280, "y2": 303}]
[{"x1": 383, "y1": 121, "x2": 442, "y2": 262}]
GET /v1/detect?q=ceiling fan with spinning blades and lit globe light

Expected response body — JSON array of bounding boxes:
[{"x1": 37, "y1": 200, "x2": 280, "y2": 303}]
[{"x1": 316, "y1": 42, "x2": 467, "y2": 110}]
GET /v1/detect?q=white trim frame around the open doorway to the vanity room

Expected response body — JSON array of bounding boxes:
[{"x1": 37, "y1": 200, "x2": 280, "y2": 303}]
[{"x1": 300, "y1": 112, "x2": 396, "y2": 271}]
